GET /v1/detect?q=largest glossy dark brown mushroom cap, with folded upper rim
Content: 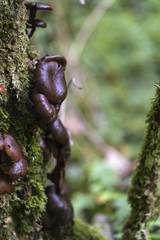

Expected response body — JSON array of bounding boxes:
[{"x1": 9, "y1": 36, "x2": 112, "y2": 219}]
[{"x1": 34, "y1": 56, "x2": 67, "y2": 105}]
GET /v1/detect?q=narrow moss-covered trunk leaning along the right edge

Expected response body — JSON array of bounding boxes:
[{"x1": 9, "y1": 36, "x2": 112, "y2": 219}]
[{"x1": 123, "y1": 89, "x2": 160, "y2": 240}]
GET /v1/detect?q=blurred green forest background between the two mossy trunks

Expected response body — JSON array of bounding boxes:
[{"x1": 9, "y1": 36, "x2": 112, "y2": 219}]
[{"x1": 32, "y1": 0, "x2": 160, "y2": 239}]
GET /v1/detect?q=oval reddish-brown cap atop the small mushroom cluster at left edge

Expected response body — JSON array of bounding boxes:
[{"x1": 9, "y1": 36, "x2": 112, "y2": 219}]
[{"x1": 3, "y1": 134, "x2": 22, "y2": 162}]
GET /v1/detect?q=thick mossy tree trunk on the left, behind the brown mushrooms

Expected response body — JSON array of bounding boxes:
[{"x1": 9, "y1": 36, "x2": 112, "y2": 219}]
[{"x1": 0, "y1": 0, "x2": 110, "y2": 240}]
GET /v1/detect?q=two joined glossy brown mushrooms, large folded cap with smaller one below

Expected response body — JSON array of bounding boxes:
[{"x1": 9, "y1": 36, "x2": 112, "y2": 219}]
[{"x1": 29, "y1": 55, "x2": 67, "y2": 124}]
